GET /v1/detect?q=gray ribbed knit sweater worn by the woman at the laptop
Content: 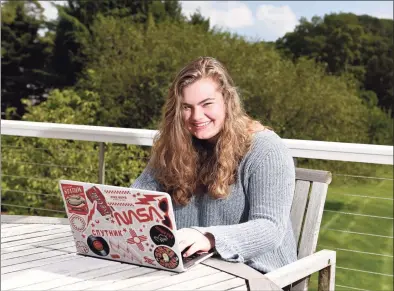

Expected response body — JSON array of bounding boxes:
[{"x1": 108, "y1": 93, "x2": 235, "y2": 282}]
[{"x1": 131, "y1": 130, "x2": 297, "y2": 273}]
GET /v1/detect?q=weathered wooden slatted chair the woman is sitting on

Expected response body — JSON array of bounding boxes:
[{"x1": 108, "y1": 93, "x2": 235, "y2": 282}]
[{"x1": 266, "y1": 168, "x2": 336, "y2": 291}]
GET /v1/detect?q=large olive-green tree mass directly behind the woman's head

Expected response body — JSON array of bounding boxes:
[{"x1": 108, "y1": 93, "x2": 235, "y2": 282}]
[{"x1": 78, "y1": 17, "x2": 376, "y2": 146}]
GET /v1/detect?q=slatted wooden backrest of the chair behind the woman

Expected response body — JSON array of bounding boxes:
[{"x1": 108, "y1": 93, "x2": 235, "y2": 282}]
[{"x1": 290, "y1": 168, "x2": 331, "y2": 290}]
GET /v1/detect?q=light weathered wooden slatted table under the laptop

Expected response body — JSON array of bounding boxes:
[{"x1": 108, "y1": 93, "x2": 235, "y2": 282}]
[{"x1": 1, "y1": 215, "x2": 281, "y2": 290}]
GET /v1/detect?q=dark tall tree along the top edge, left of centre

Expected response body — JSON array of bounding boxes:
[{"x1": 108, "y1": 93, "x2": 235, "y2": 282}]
[{"x1": 53, "y1": 0, "x2": 184, "y2": 87}]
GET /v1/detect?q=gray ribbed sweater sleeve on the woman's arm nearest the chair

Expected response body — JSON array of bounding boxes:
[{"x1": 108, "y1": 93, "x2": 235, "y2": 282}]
[{"x1": 193, "y1": 145, "x2": 295, "y2": 262}]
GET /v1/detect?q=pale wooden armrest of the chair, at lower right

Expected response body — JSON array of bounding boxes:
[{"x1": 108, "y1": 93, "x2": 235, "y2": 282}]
[{"x1": 265, "y1": 250, "x2": 336, "y2": 288}]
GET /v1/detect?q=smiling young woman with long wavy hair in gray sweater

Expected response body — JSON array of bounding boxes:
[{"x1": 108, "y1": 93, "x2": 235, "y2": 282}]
[{"x1": 132, "y1": 57, "x2": 296, "y2": 273}]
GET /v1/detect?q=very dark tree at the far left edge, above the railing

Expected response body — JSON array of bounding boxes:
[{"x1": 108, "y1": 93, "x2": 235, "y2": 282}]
[{"x1": 1, "y1": 1, "x2": 53, "y2": 118}]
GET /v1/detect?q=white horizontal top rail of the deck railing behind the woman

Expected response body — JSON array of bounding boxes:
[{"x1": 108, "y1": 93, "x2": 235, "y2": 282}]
[{"x1": 1, "y1": 120, "x2": 393, "y2": 165}]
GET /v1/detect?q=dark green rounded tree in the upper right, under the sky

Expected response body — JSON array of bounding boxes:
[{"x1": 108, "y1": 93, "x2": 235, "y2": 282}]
[{"x1": 276, "y1": 13, "x2": 394, "y2": 112}]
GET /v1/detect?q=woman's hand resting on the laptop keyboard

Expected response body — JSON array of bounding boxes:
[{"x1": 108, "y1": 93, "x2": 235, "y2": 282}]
[{"x1": 177, "y1": 228, "x2": 215, "y2": 257}]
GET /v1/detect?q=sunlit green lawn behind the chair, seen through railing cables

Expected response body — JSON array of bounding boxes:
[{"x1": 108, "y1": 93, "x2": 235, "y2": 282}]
[{"x1": 311, "y1": 166, "x2": 393, "y2": 290}]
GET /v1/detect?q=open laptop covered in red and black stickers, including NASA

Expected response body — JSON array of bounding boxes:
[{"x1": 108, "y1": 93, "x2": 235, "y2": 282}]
[{"x1": 59, "y1": 180, "x2": 213, "y2": 272}]
